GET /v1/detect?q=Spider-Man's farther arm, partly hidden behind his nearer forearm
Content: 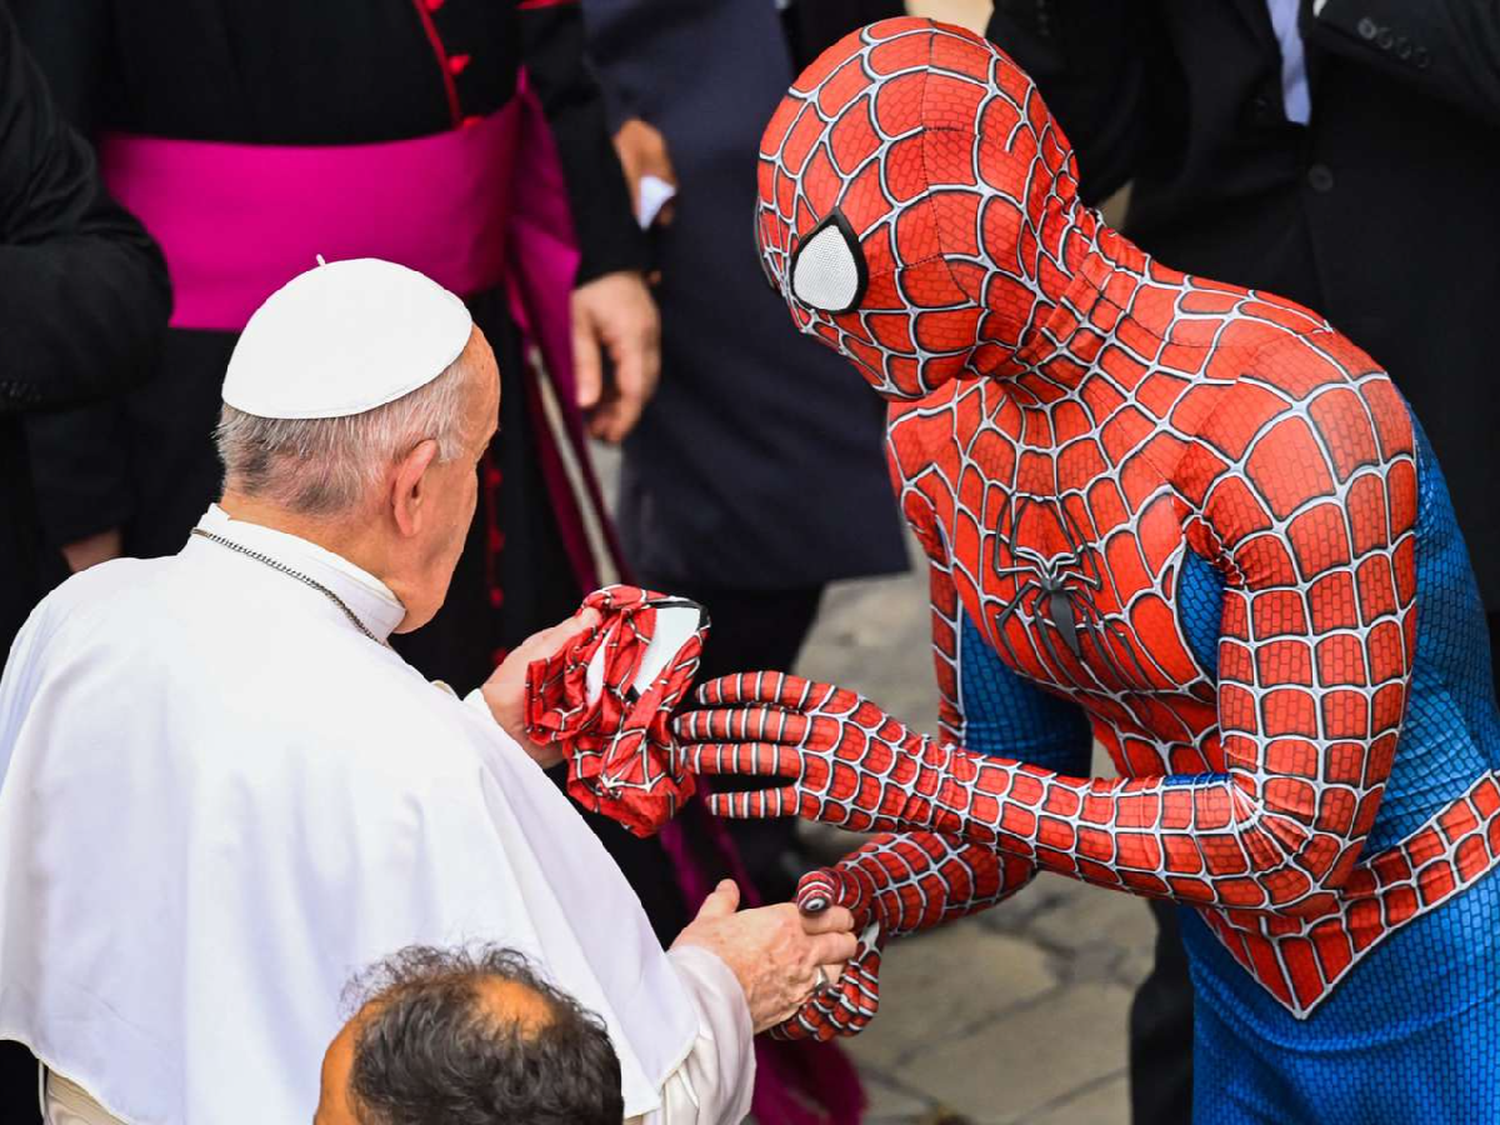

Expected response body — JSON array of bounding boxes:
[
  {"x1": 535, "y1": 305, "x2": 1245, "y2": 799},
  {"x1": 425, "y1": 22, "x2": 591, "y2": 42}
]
[{"x1": 777, "y1": 543, "x2": 1092, "y2": 1040}]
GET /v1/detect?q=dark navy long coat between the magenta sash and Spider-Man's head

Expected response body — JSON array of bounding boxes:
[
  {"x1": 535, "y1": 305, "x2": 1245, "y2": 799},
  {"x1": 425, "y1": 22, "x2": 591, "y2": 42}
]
[{"x1": 584, "y1": 0, "x2": 906, "y2": 591}]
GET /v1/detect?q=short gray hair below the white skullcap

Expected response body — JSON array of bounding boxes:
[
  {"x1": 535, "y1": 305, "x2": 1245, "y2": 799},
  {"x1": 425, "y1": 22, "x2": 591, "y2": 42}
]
[{"x1": 215, "y1": 350, "x2": 471, "y2": 518}]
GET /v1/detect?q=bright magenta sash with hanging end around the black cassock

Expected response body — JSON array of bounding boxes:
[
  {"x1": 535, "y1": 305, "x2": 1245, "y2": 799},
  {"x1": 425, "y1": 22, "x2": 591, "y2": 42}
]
[{"x1": 99, "y1": 91, "x2": 624, "y2": 590}]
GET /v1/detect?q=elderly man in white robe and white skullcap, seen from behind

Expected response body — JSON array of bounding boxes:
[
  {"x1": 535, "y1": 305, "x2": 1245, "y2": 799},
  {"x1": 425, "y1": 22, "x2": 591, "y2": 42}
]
[{"x1": 0, "y1": 260, "x2": 855, "y2": 1125}]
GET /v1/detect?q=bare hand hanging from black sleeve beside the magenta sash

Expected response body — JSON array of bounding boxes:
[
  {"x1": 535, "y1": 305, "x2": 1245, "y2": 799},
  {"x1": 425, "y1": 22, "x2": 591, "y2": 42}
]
[{"x1": 573, "y1": 272, "x2": 662, "y2": 441}]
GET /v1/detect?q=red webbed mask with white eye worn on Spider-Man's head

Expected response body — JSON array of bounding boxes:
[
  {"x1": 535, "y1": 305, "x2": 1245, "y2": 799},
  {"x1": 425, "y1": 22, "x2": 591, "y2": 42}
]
[{"x1": 756, "y1": 20, "x2": 1095, "y2": 399}]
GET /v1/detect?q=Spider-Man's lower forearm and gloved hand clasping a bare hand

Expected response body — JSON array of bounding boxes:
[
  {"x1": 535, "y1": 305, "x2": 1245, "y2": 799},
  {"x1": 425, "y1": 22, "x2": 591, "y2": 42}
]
[{"x1": 774, "y1": 833, "x2": 1032, "y2": 1040}]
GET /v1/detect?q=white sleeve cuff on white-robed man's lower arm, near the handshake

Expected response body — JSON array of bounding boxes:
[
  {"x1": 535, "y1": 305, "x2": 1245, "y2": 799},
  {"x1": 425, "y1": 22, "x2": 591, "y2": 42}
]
[{"x1": 627, "y1": 945, "x2": 755, "y2": 1125}]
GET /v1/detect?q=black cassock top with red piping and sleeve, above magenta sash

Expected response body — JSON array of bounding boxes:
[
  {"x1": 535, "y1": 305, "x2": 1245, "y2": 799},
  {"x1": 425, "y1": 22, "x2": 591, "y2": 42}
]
[{"x1": 5, "y1": 0, "x2": 644, "y2": 281}]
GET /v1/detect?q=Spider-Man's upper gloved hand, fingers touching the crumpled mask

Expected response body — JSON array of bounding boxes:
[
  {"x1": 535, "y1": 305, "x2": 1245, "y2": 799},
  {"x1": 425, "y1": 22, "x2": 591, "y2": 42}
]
[{"x1": 672, "y1": 672, "x2": 977, "y2": 833}]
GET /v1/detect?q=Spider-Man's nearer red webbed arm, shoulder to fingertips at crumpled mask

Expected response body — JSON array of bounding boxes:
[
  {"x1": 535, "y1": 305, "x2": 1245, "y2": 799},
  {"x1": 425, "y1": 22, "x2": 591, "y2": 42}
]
[{"x1": 677, "y1": 363, "x2": 1416, "y2": 915}]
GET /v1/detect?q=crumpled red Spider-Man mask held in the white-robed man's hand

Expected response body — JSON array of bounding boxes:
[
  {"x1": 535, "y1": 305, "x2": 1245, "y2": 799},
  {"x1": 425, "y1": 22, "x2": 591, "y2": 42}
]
[{"x1": 527, "y1": 587, "x2": 708, "y2": 836}]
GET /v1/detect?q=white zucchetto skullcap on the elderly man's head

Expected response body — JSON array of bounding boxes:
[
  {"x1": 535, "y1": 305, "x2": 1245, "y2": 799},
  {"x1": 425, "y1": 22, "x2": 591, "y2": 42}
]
[{"x1": 224, "y1": 258, "x2": 474, "y2": 419}]
